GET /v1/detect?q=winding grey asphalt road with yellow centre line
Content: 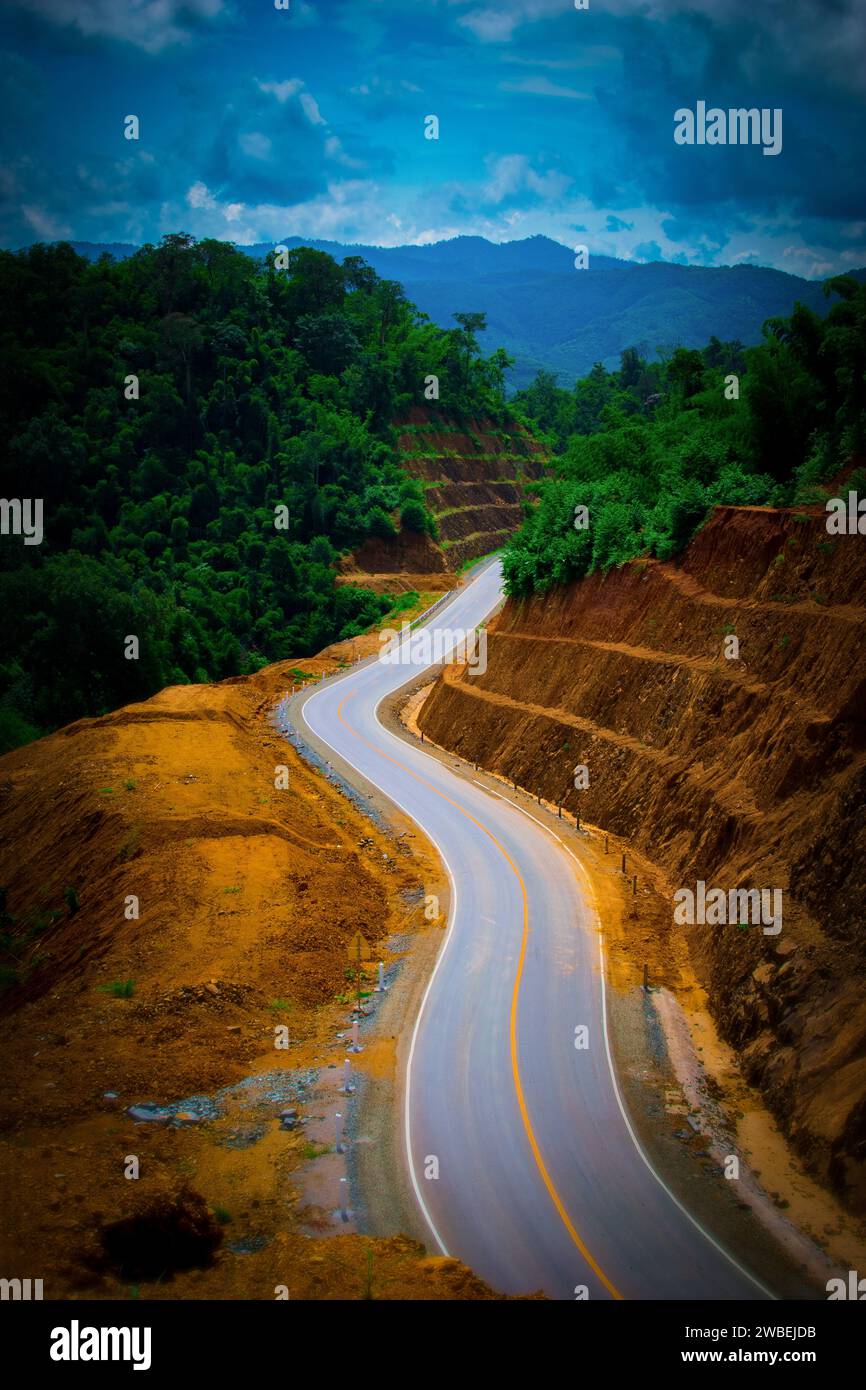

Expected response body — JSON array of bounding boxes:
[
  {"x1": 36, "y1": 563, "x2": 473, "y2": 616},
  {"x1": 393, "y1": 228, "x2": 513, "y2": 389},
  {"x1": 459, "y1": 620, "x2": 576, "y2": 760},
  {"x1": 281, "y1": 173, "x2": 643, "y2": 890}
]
[{"x1": 289, "y1": 562, "x2": 771, "y2": 1300}]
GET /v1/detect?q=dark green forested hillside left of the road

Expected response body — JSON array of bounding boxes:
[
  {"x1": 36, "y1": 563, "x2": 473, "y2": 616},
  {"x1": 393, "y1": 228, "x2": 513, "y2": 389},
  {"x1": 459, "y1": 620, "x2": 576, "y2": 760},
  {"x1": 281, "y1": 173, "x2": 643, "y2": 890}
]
[{"x1": 0, "y1": 235, "x2": 509, "y2": 752}]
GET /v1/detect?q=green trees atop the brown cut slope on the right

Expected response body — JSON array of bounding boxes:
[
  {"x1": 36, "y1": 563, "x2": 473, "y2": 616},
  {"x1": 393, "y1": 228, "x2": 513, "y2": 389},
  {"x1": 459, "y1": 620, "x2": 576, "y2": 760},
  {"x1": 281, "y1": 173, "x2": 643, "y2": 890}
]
[{"x1": 503, "y1": 277, "x2": 866, "y2": 596}]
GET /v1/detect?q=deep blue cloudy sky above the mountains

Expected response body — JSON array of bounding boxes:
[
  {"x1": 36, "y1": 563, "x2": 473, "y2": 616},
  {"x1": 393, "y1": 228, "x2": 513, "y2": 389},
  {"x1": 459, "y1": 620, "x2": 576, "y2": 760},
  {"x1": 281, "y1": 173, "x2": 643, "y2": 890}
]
[{"x1": 0, "y1": 0, "x2": 866, "y2": 277}]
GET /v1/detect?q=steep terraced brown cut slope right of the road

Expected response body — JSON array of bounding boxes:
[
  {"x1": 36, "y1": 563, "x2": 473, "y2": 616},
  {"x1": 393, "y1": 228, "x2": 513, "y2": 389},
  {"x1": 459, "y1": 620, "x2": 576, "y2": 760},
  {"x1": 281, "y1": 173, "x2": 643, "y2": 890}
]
[{"x1": 420, "y1": 507, "x2": 866, "y2": 1213}]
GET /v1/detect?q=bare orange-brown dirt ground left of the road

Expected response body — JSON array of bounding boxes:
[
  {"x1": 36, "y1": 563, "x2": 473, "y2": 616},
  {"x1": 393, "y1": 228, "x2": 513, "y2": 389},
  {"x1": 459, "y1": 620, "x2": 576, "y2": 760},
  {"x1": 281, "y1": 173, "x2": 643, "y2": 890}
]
[{"x1": 0, "y1": 667, "x2": 508, "y2": 1298}]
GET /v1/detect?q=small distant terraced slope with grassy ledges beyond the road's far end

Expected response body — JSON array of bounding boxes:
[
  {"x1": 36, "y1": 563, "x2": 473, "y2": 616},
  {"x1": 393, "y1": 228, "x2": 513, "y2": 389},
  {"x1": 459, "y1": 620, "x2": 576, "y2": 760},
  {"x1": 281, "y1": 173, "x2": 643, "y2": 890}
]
[{"x1": 398, "y1": 406, "x2": 548, "y2": 570}]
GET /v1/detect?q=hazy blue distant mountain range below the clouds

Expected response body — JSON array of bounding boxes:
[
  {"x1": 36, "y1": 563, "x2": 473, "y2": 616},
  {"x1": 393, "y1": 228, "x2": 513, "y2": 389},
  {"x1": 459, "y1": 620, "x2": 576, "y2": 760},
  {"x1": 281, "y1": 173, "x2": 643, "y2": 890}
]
[{"x1": 62, "y1": 236, "x2": 866, "y2": 386}]
